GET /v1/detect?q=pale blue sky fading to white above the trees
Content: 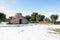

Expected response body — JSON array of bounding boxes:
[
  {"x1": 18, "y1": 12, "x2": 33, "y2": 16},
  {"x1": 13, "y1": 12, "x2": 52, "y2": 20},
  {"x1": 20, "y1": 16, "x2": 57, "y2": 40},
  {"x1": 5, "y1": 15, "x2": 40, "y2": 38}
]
[{"x1": 0, "y1": 0, "x2": 60, "y2": 20}]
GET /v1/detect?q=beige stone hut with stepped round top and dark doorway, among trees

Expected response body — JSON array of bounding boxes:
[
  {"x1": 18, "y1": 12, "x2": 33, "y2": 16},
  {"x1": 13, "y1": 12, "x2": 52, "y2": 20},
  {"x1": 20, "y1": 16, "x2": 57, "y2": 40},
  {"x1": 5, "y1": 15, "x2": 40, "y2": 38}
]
[{"x1": 10, "y1": 13, "x2": 28, "y2": 24}]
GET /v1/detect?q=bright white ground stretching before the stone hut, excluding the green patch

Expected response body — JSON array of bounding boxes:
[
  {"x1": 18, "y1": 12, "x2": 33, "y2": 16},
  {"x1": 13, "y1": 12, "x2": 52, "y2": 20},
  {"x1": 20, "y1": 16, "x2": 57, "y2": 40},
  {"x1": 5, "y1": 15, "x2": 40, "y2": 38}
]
[{"x1": 0, "y1": 24, "x2": 60, "y2": 40}]
